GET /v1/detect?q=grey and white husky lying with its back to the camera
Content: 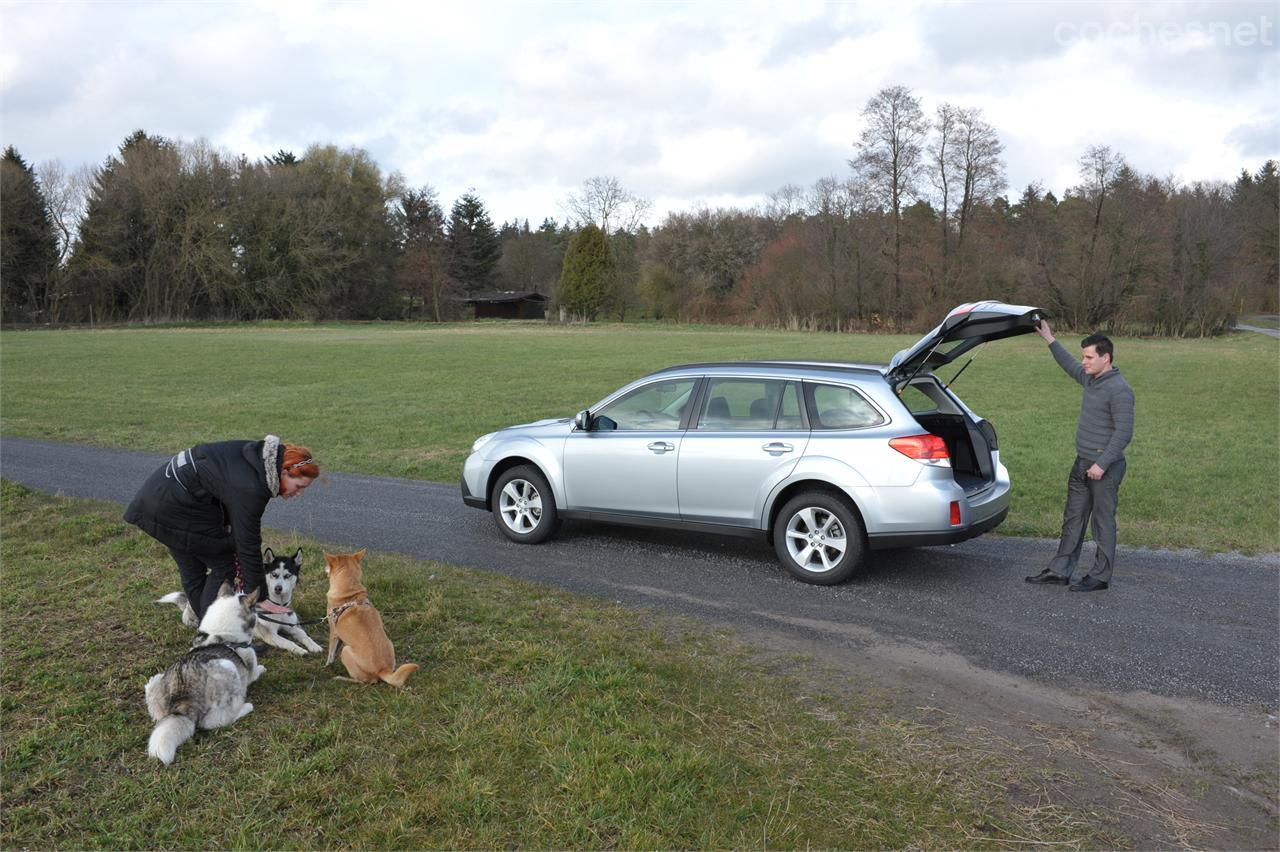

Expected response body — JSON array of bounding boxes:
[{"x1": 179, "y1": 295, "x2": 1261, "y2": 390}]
[{"x1": 146, "y1": 583, "x2": 266, "y2": 765}]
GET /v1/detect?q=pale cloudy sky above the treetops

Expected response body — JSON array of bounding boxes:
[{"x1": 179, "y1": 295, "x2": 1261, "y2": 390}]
[{"x1": 0, "y1": 0, "x2": 1280, "y2": 226}]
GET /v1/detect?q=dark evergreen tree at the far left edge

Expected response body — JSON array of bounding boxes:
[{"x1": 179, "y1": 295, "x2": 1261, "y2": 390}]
[{"x1": 0, "y1": 145, "x2": 58, "y2": 322}]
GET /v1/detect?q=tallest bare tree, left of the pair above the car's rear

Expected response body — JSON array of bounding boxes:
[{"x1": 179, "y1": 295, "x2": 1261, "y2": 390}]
[{"x1": 850, "y1": 86, "x2": 929, "y2": 326}]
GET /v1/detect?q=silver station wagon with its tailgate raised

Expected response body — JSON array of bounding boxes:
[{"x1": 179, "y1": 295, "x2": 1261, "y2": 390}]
[{"x1": 462, "y1": 302, "x2": 1042, "y2": 585}]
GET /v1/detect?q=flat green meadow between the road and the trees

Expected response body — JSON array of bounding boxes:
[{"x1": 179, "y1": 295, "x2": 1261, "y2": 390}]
[{"x1": 0, "y1": 322, "x2": 1280, "y2": 553}]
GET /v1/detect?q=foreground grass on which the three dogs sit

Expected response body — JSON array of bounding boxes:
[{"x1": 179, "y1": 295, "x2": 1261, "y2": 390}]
[{"x1": 0, "y1": 482, "x2": 1111, "y2": 849}]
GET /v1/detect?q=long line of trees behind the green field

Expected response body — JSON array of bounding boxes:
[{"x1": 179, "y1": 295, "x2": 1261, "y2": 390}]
[{"x1": 0, "y1": 87, "x2": 1280, "y2": 336}]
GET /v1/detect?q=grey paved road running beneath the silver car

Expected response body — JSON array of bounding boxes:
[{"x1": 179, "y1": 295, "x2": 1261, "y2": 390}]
[{"x1": 0, "y1": 438, "x2": 1280, "y2": 711}]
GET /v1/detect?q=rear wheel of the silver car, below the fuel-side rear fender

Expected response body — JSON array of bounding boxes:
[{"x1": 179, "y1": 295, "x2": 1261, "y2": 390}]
[{"x1": 773, "y1": 491, "x2": 867, "y2": 586}]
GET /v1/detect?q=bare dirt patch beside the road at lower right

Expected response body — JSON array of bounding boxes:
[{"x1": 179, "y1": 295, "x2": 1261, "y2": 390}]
[{"x1": 740, "y1": 624, "x2": 1280, "y2": 849}]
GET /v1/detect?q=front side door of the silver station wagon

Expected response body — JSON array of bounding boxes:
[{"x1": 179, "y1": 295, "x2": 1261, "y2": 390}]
[{"x1": 564, "y1": 377, "x2": 698, "y2": 518}]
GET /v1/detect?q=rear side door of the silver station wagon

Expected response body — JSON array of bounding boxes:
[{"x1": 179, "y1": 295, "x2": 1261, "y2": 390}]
[{"x1": 677, "y1": 377, "x2": 809, "y2": 526}]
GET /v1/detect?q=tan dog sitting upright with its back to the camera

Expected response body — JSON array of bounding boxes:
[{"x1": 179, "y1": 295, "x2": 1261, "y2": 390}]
[{"x1": 324, "y1": 550, "x2": 417, "y2": 686}]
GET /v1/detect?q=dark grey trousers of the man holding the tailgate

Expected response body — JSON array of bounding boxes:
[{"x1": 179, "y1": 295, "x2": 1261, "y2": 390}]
[{"x1": 1048, "y1": 458, "x2": 1125, "y2": 583}]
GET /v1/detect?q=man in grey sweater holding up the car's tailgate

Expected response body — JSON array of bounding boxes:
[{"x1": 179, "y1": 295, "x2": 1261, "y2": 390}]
[{"x1": 1027, "y1": 320, "x2": 1133, "y2": 591}]
